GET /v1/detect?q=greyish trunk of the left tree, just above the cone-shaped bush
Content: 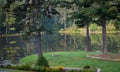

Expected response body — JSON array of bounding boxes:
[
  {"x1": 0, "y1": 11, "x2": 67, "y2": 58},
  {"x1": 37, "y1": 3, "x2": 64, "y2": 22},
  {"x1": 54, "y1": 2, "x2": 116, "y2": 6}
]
[{"x1": 35, "y1": 32, "x2": 42, "y2": 58}]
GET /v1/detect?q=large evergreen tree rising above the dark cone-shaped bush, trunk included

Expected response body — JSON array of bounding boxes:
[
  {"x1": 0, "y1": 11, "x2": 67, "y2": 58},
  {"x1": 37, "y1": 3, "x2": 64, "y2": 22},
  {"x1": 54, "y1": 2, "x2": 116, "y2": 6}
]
[{"x1": 4, "y1": 0, "x2": 58, "y2": 57}]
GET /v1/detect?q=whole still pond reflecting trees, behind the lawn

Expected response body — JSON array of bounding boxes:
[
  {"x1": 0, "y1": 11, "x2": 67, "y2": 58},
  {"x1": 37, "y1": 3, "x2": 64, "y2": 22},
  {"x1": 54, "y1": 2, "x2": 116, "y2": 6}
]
[{"x1": 0, "y1": 33, "x2": 120, "y2": 63}]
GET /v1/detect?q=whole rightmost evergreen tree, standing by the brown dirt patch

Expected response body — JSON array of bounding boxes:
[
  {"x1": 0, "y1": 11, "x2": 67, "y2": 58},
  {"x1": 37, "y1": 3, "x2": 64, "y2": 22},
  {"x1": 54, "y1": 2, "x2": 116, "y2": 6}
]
[{"x1": 92, "y1": 0, "x2": 120, "y2": 54}]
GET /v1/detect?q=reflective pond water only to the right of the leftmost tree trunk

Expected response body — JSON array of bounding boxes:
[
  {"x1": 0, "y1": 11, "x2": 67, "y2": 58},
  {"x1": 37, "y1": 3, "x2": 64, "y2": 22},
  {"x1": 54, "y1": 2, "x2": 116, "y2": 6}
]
[{"x1": 43, "y1": 33, "x2": 120, "y2": 53}]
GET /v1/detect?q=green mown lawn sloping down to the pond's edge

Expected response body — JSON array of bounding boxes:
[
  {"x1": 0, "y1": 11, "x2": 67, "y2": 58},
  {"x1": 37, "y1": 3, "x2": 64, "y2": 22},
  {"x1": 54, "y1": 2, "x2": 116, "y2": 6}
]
[{"x1": 21, "y1": 51, "x2": 120, "y2": 72}]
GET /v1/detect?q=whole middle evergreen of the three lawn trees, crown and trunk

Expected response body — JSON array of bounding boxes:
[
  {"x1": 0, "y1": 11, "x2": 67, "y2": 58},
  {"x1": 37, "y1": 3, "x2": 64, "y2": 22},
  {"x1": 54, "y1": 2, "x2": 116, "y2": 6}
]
[{"x1": 72, "y1": 0, "x2": 93, "y2": 51}]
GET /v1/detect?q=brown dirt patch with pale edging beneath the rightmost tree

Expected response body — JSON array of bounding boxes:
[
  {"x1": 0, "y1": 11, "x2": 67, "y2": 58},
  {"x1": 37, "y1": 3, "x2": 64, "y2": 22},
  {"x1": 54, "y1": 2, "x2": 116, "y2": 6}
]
[{"x1": 87, "y1": 54, "x2": 120, "y2": 61}]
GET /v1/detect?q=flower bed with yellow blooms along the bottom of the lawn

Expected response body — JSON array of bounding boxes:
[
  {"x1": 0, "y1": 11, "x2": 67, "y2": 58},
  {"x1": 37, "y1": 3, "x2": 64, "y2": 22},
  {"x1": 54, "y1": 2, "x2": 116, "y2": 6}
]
[{"x1": 0, "y1": 64, "x2": 97, "y2": 72}]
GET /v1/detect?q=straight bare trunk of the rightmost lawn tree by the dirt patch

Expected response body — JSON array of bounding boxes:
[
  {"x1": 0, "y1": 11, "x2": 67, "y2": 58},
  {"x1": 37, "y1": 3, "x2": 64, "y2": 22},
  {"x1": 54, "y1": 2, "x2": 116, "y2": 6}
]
[{"x1": 102, "y1": 18, "x2": 107, "y2": 54}]
